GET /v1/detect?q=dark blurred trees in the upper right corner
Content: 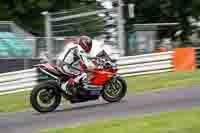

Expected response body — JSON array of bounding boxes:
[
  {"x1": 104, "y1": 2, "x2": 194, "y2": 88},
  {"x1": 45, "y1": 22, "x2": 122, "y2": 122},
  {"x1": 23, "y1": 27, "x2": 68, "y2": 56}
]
[{"x1": 129, "y1": 0, "x2": 200, "y2": 41}]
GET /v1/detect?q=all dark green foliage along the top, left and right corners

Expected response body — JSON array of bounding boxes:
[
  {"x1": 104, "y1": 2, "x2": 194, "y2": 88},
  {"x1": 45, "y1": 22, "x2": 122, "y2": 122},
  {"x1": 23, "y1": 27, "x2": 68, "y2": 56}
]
[{"x1": 0, "y1": 0, "x2": 200, "y2": 40}]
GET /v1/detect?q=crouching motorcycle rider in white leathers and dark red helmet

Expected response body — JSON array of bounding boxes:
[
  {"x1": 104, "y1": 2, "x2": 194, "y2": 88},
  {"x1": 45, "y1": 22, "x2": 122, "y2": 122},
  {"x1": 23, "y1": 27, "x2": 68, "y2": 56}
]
[{"x1": 57, "y1": 36, "x2": 95, "y2": 95}]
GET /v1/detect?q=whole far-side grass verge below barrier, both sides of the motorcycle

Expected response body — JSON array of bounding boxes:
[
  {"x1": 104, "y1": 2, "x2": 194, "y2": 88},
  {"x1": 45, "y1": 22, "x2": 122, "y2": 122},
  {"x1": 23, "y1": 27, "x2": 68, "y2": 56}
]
[{"x1": 0, "y1": 70, "x2": 200, "y2": 112}]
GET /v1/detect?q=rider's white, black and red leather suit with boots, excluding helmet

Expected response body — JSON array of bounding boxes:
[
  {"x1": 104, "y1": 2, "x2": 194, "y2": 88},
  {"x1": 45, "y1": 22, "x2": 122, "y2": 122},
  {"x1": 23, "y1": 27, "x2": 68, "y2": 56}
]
[{"x1": 57, "y1": 42, "x2": 96, "y2": 95}]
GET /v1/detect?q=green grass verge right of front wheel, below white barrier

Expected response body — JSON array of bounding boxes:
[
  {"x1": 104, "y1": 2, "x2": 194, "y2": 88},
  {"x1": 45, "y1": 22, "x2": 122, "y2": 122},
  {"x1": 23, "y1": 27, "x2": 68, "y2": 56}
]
[{"x1": 126, "y1": 70, "x2": 200, "y2": 92}]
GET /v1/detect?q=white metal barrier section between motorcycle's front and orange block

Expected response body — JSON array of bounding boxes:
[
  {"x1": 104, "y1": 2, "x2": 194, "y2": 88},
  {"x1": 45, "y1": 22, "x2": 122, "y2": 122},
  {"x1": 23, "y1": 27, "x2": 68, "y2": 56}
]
[{"x1": 118, "y1": 51, "x2": 173, "y2": 77}]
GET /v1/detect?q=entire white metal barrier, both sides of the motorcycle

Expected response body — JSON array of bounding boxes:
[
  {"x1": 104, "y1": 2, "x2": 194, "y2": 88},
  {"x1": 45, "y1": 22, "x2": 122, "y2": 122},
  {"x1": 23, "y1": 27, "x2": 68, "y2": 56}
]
[{"x1": 0, "y1": 51, "x2": 173, "y2": 95}]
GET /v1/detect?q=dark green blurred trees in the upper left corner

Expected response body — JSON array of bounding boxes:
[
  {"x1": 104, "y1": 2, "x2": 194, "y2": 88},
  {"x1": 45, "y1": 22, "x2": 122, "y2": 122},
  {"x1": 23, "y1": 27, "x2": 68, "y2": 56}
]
[{"x1": 0, "y1": 0, "x2": 89, "y2": 35}]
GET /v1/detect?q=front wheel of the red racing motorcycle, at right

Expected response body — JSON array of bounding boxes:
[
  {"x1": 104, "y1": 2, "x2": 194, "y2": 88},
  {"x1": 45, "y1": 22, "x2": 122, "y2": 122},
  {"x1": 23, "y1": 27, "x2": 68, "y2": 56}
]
[{"x1": 102, "y1": 77, "x2": 127, "y2": 102}]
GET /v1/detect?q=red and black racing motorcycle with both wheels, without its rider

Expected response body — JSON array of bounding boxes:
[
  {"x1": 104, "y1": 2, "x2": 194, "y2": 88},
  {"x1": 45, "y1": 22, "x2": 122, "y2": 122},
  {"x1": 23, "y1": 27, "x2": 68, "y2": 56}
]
[{"x1": 30, "y1": 51, "x2": 127, "y2": 113}]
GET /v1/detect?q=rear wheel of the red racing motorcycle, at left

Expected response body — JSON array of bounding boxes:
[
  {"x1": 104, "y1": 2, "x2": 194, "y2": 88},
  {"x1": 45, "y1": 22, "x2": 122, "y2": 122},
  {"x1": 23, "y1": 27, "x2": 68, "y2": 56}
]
[{"x1": 30, "y1": 81, "x2": 61, "y2": 113}]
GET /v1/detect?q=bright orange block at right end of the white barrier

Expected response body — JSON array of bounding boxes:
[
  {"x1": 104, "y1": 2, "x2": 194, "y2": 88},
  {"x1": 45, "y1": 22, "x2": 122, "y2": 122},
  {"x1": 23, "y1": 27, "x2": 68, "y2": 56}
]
[{"x1": 173, "y1": 48, "x2": 197, "y2": 71}]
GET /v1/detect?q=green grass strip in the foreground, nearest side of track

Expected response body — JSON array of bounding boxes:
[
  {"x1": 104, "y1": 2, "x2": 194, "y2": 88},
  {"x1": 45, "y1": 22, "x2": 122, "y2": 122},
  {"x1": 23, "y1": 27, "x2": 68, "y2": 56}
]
[{"x1": 40, "y1": 109, "x2": 200, "y2": 133}]
